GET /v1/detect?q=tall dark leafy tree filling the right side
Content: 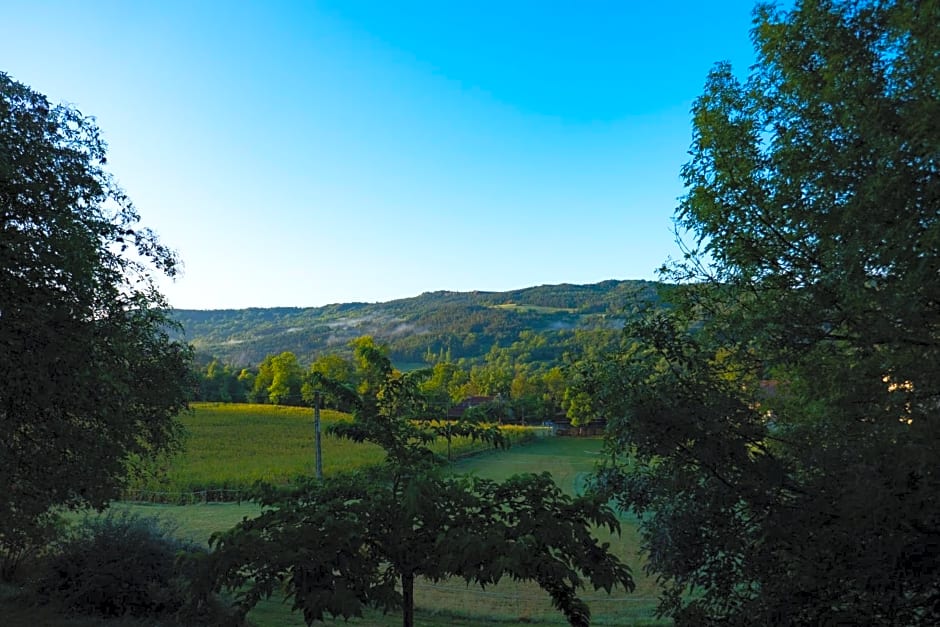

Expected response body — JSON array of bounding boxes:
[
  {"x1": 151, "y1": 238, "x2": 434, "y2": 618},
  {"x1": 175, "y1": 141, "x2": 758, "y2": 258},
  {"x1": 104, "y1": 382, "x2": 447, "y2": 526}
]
[{"x1": 585, "y1": 0, "x2": 940, "y2": 625}]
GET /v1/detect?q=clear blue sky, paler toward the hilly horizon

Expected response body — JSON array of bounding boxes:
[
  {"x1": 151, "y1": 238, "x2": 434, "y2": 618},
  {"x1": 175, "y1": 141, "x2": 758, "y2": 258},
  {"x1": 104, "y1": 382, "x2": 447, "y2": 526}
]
[{"x1": 0, "y1": 0, "x2": 754, "y2": 309}]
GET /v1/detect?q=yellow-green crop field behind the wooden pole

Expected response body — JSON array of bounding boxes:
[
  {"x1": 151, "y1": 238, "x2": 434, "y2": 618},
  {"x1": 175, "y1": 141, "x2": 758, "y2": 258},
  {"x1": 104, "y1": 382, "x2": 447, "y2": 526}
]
[{"x1": 124, "y1": 403, "x2": 535, "y2": 503}]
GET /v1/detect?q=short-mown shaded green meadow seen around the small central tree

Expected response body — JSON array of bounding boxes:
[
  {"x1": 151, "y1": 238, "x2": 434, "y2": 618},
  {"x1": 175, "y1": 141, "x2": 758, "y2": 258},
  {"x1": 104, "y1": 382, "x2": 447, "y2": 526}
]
[{"x1": 116, "y1": 438, "x2": 660, "y2": 627}]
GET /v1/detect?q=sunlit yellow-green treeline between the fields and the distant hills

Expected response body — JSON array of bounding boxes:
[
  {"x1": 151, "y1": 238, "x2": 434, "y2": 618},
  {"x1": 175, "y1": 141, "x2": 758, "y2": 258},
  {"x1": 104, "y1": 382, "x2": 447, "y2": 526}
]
[{"x1": 193, "y1": 329, "x2": 620, "y2": 425}]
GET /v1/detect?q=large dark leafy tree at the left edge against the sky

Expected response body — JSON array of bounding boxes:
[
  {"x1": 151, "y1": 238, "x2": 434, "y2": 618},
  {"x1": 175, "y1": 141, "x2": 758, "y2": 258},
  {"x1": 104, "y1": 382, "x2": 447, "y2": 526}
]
[{"x1": 0, "y1": 73, "x2": 190, "y2": 575}]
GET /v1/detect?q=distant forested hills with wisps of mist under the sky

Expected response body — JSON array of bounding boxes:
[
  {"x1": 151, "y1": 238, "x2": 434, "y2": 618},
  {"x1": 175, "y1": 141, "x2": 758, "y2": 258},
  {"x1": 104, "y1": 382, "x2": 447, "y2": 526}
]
[{"x1": 173, "y1": 280, "x2": 660, "y2": 367}]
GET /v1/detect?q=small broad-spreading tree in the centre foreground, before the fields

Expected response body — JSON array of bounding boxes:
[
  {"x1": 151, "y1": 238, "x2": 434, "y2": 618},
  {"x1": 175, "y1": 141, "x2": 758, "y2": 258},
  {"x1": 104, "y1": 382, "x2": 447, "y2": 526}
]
[{"x1": 203, "y1": 339, "x2": 633, "y2": 627}]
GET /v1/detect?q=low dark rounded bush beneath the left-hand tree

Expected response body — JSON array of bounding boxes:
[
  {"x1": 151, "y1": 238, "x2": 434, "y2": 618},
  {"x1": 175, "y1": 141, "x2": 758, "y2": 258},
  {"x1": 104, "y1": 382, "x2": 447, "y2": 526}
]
[{"x1": 36, "y1": 512, "x2": 205, "y2": 617}]
